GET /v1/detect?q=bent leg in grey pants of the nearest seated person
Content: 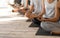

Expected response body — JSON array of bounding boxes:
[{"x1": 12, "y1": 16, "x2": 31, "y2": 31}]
[{"x1": 41, "y1": 22, "x2": 60, "y2": 31}]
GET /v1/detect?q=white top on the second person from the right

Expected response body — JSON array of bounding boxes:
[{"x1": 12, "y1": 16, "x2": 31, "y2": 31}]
[{"x1": 30, "y1": 0, "x2": 42, "y2": 14}]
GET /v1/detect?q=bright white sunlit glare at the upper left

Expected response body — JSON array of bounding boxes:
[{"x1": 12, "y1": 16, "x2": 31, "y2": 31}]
[{"x1": 0, "y1": 0, "x2": 28, "y2": 21}]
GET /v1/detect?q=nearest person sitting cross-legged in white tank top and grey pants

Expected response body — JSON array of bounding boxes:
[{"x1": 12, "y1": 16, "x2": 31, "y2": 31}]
[{"x1": 39, "y1": 0, "x2": 60, "y2": 34}]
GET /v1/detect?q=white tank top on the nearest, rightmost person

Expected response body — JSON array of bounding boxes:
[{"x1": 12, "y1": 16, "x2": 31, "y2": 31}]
[{"x1": 44, "y1": 0, "x2": 57, "y2": 18}]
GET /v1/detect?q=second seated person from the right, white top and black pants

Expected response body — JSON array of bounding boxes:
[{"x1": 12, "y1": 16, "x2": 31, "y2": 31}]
[{"x1": 25, "y1": 0, "x2": 42, "y2": 25}]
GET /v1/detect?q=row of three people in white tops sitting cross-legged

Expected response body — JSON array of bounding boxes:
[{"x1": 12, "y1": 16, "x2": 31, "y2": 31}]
[{"x1": 13, "y1": 0, "x2": 60, "y2": 34}]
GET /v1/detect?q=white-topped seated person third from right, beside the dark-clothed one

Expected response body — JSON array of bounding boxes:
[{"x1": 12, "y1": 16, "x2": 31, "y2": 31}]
[{"x1": 13, "y1": 0, "x2": 29, "y2": 14}]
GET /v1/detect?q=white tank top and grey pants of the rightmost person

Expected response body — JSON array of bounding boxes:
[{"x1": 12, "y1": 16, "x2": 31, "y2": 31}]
[{"x1": 41, "y1": 0, "x2": 60, "y2": 31}]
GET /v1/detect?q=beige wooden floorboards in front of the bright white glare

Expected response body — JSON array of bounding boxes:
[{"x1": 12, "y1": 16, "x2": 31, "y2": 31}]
[{"x1": 0, "y1": 16, "x2": 60, "y2": 38}]
